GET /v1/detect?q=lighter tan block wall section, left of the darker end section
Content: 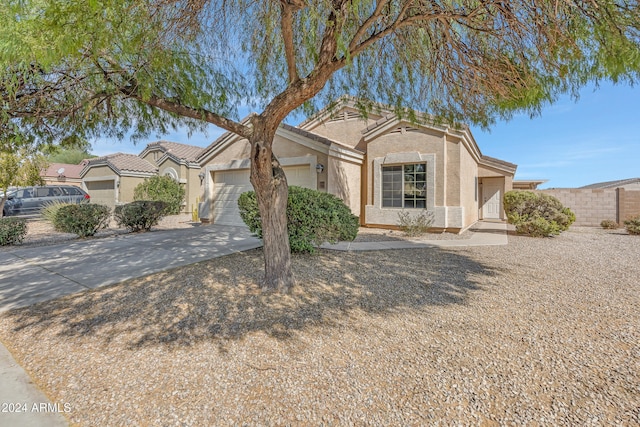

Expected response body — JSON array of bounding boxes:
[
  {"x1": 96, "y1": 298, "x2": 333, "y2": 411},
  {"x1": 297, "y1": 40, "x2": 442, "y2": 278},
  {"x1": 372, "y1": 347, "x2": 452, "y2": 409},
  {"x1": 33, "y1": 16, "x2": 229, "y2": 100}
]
[{"x1": 538, "y1": 188, "x2": 618, "y2": 227}]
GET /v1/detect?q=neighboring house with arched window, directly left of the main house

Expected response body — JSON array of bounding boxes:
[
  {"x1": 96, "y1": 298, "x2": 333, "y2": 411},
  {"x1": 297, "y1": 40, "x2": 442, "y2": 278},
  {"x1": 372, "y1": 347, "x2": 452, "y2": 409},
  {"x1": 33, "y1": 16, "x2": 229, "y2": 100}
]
[{"x1": 139, "y1": 141, "x2": 202, "y2": 212}]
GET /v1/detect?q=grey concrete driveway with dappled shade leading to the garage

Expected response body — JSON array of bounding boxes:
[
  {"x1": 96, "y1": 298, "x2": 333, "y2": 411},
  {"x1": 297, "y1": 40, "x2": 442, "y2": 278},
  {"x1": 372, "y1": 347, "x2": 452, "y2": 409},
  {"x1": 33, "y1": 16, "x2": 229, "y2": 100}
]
[{"x1": 0, "y1": 225, "x2": 262, "y2": 312}]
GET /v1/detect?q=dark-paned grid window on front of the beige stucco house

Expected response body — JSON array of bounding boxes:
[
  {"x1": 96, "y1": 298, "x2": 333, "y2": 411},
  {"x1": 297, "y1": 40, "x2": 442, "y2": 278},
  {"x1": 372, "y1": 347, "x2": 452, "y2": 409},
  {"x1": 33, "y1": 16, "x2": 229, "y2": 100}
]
[{"x1": 382, "y1": 163, "x2": 427, "y2": 209}]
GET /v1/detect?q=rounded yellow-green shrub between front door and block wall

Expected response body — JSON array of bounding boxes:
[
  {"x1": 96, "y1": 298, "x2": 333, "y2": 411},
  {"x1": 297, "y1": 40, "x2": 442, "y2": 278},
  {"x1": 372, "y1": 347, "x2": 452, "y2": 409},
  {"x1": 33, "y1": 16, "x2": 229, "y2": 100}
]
[{"x1": 504, "y1": 191, "x2": 576, "y2": 237}]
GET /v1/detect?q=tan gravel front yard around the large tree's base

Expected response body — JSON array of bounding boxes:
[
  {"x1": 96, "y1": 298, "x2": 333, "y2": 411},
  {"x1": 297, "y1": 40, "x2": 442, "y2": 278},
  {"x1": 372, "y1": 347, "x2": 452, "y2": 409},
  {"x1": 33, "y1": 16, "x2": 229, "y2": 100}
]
[{"x1": 0, "y1": 228, "x2": 640, "y2": 426}]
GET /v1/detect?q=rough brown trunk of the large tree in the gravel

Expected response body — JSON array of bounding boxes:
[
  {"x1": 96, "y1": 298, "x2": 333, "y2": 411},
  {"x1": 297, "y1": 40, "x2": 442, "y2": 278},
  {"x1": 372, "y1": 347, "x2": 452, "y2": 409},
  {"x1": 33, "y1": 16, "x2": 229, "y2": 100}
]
[{"x1": 250, "y1": 123, "x2": 295, "y2": 293}]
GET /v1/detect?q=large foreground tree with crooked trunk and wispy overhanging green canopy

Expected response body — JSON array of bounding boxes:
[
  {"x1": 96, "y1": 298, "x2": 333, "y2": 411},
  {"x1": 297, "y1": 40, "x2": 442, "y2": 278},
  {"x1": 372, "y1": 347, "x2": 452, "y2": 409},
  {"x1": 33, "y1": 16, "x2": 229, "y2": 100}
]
[{"x1": 0, "y1": 0, "x2": 640, "y2": 291}]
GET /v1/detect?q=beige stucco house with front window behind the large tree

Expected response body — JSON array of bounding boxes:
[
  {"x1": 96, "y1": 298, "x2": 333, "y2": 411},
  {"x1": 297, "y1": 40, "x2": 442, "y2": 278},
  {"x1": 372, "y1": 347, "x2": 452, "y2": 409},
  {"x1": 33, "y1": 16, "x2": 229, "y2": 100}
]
[{"x1": 198, "y1": 99, "x2": 516, "y2": 232}]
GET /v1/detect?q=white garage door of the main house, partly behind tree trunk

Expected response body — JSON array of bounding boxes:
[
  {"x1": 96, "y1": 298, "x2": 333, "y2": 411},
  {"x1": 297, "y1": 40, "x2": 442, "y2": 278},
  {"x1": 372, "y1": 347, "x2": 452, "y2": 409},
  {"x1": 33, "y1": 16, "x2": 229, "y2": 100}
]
[{"x1": 213, "y1": 165, "x2": 313, "y2": 225}]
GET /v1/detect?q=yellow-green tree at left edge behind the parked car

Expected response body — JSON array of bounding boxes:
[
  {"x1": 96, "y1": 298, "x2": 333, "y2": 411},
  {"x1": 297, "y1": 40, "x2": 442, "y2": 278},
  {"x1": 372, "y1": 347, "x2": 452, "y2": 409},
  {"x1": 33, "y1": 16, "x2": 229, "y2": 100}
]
[{"x1": 0, "y1": 147, "x2": 47, "y2": 216}]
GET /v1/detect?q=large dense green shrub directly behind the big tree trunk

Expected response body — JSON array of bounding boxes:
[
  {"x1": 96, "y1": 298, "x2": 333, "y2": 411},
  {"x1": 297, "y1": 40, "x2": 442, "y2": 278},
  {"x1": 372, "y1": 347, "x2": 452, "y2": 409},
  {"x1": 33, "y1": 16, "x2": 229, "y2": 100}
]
[{"x1": 238, "y1": 186, "x2": 359, "y2": 253}]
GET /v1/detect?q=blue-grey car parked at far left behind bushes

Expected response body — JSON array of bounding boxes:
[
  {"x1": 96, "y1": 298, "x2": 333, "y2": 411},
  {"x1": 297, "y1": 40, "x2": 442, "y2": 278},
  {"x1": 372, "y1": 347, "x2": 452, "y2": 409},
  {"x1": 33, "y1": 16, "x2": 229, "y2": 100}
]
[{"x1": 2, "y1": 185, "x2": 90, "y2": 216}]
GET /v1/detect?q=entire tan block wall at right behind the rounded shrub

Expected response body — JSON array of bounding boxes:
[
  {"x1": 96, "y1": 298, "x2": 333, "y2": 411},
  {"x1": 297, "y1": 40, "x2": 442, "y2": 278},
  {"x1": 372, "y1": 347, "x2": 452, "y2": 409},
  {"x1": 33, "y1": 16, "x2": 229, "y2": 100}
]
[{"x1": 537, "y1": 188, "x2": 640, "y2": 227}]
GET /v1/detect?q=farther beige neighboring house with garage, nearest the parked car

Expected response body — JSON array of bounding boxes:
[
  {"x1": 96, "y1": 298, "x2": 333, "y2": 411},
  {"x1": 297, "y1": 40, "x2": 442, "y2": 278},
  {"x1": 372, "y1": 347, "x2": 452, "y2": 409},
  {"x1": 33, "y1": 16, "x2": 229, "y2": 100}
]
[{"x1": 80, "y1": 153, "x2": 158, "y2": 208}]
